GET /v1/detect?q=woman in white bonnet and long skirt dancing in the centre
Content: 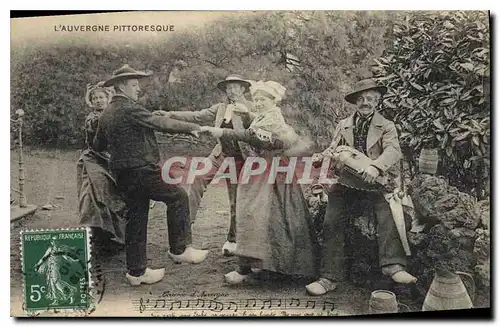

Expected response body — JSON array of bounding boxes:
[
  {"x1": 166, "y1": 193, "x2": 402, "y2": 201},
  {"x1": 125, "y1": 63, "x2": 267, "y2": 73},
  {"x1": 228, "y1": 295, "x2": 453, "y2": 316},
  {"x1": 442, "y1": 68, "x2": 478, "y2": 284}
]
[{"x1": 205, "y1": 81, "x2": 318, "y2": 284}]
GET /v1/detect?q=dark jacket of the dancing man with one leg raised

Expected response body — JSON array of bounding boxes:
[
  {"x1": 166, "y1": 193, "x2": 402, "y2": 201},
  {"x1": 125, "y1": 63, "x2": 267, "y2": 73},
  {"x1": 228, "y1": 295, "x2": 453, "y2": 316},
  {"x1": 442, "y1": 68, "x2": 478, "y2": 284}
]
[{"x1": 94, "y1": 94, "x2": 199, "y2": 170}]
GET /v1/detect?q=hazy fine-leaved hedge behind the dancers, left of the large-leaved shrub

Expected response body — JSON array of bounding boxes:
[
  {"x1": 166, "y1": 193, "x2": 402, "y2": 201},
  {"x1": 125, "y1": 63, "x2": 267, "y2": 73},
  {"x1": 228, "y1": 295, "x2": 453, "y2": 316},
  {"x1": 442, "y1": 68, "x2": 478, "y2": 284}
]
[{"x1": 11, "y1": 11, "x2": 393, "y2": 148}]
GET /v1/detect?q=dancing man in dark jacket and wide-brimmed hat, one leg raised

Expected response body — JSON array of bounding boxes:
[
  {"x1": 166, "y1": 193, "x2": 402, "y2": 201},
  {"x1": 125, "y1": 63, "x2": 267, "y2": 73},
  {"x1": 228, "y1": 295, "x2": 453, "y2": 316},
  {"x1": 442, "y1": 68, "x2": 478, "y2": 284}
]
[{"x1": 94, "y1": 65, "x2": 208, "y2": 285}]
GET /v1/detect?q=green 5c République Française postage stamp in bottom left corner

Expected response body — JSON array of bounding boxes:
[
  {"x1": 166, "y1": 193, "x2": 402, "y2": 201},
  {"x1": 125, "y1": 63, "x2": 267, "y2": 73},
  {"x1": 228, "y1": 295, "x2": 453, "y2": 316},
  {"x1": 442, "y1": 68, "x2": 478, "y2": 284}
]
[{"x1": 21, "y1": 228, "x2": 91, "y2": 312}]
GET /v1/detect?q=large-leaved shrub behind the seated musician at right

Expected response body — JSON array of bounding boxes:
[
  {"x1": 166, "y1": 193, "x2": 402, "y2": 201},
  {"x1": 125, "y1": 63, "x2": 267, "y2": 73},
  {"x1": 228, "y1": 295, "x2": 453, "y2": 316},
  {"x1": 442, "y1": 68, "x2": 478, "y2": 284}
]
[{"x1": 373, "y1": 12, "x2": 491, "y2": 198}]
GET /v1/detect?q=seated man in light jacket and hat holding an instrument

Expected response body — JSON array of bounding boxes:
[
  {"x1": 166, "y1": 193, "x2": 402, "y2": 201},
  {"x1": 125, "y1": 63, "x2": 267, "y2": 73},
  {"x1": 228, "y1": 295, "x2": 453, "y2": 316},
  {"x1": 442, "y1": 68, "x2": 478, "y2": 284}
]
[{"x1": 306, "y1": 79, "x2": 416, "y2": 295}]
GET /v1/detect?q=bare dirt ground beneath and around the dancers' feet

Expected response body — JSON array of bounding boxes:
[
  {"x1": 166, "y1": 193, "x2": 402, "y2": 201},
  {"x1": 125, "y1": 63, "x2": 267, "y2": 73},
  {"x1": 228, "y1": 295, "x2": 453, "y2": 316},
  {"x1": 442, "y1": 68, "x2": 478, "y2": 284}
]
[{"x1": 11, "y1": 151, "x2": 369, "y2": 315}]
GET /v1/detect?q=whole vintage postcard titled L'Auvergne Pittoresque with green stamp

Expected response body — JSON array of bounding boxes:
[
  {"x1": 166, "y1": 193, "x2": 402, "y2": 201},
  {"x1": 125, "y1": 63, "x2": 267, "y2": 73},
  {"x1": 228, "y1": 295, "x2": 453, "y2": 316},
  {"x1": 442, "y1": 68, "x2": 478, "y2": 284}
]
[{"x1": 10, "y1": 11, "x2": 492, "y2": 318}]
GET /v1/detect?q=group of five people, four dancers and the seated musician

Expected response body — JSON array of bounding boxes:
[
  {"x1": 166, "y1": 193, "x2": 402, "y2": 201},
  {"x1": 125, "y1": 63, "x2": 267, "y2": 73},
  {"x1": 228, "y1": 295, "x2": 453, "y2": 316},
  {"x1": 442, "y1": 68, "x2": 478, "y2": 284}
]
[{"x1": 78, "y1": 65, "x2": 416, "y2": 295}]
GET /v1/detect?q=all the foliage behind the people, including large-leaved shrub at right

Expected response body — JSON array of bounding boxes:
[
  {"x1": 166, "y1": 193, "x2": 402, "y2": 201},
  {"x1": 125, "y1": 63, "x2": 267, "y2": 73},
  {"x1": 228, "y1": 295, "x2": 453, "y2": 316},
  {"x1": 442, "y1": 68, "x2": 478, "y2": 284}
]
[{"x1": 11, "y1": 11, "x2": 490, "y2": 197}]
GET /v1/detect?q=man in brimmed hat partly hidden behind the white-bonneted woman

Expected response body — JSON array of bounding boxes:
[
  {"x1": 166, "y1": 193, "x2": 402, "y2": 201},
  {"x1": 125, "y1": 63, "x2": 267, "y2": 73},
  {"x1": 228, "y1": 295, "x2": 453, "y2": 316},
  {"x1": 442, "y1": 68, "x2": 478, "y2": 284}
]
[{"x1": 158, "y1": 75, "x2": 253, "y2": 256}]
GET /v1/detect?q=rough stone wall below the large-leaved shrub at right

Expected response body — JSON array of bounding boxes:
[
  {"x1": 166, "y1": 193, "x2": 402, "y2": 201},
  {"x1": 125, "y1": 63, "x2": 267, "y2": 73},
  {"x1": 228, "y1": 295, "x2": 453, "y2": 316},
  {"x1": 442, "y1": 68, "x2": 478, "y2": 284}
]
[{"x1": 409, "y1": 174, "x2": 490, "y2": 298}]
